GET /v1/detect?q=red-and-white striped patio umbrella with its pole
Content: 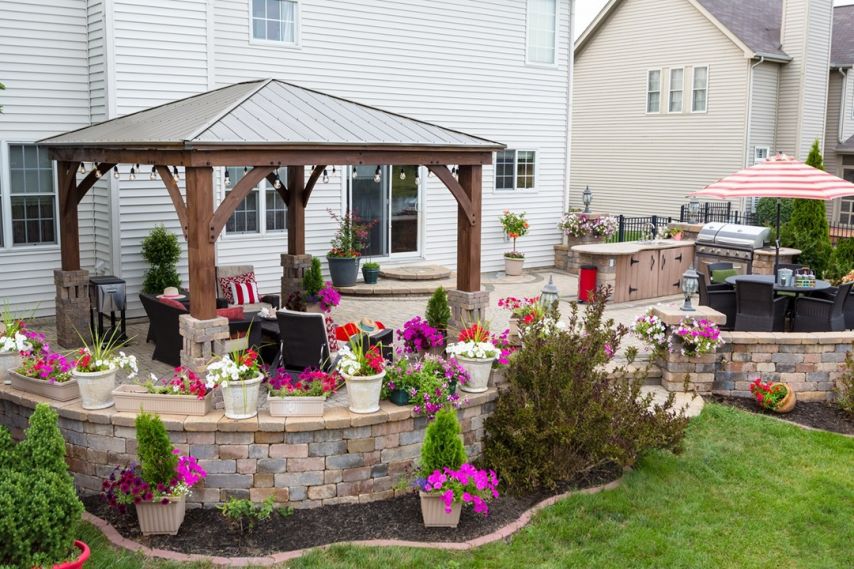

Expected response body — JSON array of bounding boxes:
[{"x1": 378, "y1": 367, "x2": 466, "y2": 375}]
[{"x1": 691, "y1": 154, "x2": 854, "y2": 266}]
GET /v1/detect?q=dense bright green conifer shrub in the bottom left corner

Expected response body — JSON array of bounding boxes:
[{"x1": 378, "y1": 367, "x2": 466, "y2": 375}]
[{"x1": 0, "y1": 403, "x2": 89, "y2": 569}]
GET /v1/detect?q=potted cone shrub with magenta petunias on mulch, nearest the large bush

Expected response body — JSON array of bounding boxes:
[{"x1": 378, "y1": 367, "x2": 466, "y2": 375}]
[{"x1": 419, "y1": 408, "x2": 498, "y2": 528}]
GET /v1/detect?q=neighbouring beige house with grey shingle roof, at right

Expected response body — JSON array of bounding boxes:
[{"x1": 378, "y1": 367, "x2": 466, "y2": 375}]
[{"x1": 570, "y1": 0, "x2": 854, "y2": 223}]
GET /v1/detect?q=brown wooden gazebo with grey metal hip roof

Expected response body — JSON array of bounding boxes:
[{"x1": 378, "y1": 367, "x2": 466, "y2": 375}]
[{"x1": 40, "y1": 79, "x2": 504, "y2": 348}]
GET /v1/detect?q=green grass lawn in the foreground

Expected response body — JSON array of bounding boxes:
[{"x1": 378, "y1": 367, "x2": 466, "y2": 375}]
[{"x1": 77, "y1": 404, "x2": 854, "y2": 569}]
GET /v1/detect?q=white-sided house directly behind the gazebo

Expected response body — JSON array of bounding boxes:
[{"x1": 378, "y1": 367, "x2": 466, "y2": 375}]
[{"x1": 0, "y1": 0, "x2": 573, "y2": 315}]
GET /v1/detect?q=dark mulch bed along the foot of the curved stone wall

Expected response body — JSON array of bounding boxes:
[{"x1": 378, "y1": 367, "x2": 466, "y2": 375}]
[{"x1": 83, "y1": 464, "x2": 623, "y2": 557}]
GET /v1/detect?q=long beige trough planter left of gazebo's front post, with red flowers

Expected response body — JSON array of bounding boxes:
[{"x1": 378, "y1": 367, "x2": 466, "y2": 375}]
[{"x1": 113, "y1": 367, "x2": 213, "y2": 416}]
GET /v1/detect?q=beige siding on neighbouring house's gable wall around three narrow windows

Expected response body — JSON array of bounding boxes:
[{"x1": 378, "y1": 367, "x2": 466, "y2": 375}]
[{"x1": 570, "y1": 0, "x2": 749, "y2": 216}]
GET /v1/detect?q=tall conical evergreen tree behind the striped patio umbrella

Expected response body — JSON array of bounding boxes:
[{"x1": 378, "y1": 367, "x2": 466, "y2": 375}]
[{"x1": 781, "y1": 140, "x2": 833, "y2": 278}]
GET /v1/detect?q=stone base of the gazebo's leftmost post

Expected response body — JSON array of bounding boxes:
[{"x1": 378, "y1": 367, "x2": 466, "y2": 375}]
[{"x1": 53, "y1": 269, "x2": 91, "y2": 348}]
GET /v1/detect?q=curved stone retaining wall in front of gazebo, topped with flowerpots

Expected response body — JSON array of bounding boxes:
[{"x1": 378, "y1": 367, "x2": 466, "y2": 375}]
[{"x1": 0, "y1": 385, "x2": 498, "y2": 508}]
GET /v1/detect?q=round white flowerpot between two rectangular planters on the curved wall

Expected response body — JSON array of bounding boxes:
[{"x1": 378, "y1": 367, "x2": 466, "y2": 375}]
[{"x1": 205, "y1": 348, "x2": 264, "y2": 419}]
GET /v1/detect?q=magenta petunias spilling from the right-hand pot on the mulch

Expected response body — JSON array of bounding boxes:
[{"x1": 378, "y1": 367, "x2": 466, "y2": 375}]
[{"x1": 421, "y1": 463, "x2": 498, "y2": 516}]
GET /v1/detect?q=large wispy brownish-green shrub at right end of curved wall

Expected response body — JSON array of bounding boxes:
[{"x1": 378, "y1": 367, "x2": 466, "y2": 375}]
[{"x1": 484, "y1": 290, "x2": 687, "y2": 493}]
